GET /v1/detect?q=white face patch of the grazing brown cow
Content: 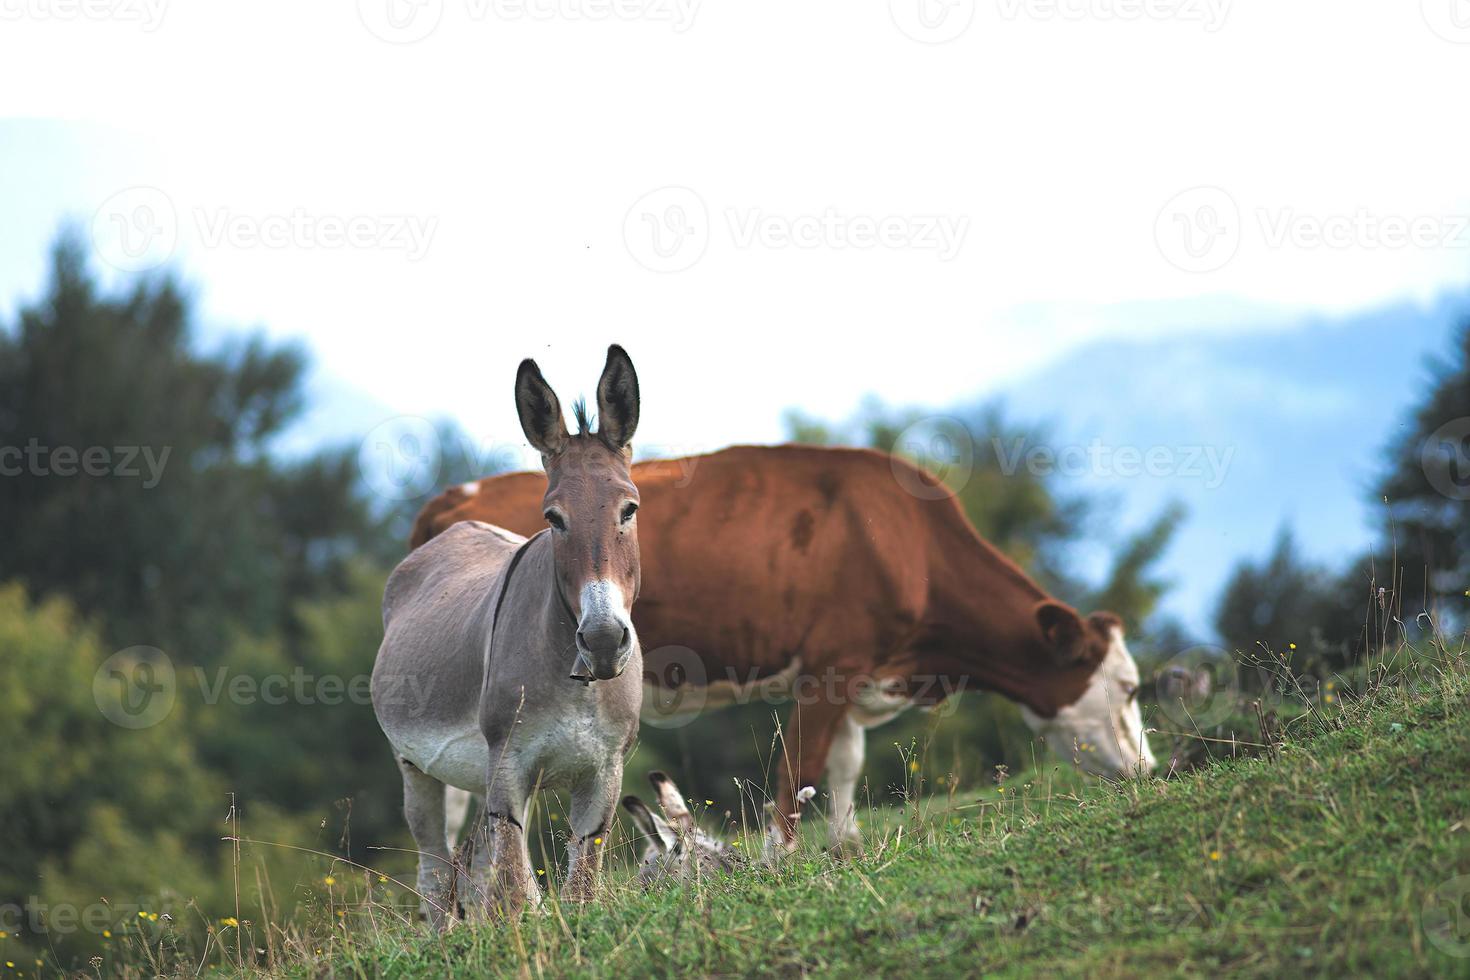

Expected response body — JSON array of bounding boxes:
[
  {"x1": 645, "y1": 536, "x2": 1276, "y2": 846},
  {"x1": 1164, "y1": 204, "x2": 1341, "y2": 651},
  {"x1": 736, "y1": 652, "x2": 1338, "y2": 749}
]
[{"x1": 1020, "y1": 629, "x2": 1154, "y2": 777}]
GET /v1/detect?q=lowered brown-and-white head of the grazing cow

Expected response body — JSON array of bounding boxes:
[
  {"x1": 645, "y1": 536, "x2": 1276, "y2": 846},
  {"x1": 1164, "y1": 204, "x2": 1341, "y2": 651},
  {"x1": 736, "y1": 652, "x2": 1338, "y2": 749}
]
[{"x1": 1022, "y1": 601, "x2": 1154, "y2": 777}]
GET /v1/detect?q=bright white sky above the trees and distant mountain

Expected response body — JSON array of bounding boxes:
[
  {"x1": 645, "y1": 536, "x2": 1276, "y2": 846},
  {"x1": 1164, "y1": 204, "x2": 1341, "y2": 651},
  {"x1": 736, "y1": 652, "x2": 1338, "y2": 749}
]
[{"x1": 0, "y1": 0, "x2": 1470, "y2": 637}]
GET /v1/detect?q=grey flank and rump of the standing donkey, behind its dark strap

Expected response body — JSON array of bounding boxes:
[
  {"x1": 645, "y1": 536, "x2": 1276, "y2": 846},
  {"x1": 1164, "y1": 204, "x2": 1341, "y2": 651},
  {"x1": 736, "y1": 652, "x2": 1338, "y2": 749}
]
[{"x1": 372, "y1": 522, "x2": 525, "y2": 792}]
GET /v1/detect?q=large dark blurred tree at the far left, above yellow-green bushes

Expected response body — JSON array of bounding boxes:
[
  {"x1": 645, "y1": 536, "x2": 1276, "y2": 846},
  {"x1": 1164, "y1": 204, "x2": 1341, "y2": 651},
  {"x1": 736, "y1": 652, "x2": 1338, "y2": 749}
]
[{"x1": 0, "y1": 232, "x2": 385, "y2": 661}]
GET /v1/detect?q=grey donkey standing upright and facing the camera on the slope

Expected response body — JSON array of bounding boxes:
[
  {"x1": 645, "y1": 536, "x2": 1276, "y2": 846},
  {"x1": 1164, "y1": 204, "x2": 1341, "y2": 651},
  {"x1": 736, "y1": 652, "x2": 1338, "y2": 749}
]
[{"x1": 372, "y1": 345, "x2": 642, "y2": 927}]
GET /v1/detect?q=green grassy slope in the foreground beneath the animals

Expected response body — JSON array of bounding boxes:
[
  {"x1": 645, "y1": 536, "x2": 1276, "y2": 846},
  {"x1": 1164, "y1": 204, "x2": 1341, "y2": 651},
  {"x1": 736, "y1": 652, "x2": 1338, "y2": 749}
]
[{"x1": 264, "y1": 664, "x2": 1470, "y2": 977}]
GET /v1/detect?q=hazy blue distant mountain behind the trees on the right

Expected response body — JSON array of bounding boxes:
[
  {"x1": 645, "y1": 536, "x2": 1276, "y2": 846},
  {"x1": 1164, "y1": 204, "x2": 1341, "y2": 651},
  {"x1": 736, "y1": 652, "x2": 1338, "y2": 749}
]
[{"x1": 994, "y1": 298, "x2": 1470, "y2": 638}]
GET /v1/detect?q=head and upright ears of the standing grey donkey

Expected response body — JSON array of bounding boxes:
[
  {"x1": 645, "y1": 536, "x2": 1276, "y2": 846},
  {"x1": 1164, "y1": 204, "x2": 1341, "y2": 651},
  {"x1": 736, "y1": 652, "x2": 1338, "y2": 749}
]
[{"x1": 516, "y1": 344, "x2": 639, "y2": 680}]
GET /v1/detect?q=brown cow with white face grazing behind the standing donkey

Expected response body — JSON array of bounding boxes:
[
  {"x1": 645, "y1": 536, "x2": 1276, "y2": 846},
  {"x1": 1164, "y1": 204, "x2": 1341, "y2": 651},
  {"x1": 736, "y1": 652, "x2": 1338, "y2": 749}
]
[{"x1": 412, "y1": 445, "x2": 1154, "y2": 846}]
